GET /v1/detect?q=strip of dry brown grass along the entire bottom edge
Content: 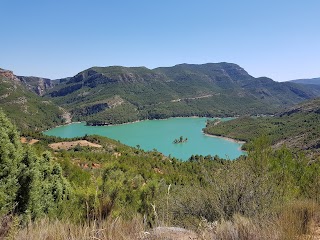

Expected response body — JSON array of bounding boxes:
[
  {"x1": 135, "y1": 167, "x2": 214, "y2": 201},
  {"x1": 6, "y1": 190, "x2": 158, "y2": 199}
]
[{"x1": 4, "y1": 201, "x2": 320, "y2": 240}]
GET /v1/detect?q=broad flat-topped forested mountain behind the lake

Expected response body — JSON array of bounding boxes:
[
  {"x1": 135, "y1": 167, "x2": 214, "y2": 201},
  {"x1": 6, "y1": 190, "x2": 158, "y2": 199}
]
[{"x1": 45, "y1": 63, "x2": 320, "y2": 124}]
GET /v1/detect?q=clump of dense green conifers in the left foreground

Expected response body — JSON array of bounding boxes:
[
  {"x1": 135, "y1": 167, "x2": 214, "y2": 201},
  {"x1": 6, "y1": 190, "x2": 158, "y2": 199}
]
[{"x1": 0, "y1": 112, "x2": 70, "y2": 220}]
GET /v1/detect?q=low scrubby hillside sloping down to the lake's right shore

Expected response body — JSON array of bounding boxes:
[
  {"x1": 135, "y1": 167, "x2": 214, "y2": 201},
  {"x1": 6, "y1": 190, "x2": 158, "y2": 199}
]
[{"x1": 205, "y1": 98, "x2": 320, "y2": 152}]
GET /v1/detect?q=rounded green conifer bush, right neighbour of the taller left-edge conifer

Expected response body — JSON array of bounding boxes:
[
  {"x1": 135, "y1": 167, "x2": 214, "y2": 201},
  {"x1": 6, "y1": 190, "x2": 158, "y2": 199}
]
[{"x1": 17, "y1": 147, "x2": 70, "y2": 220}]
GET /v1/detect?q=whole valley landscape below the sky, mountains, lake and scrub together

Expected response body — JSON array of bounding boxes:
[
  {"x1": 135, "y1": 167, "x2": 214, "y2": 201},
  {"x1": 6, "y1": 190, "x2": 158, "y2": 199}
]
[{"x1": 0, "y1": 63, "x2": 320, "y2": 239}]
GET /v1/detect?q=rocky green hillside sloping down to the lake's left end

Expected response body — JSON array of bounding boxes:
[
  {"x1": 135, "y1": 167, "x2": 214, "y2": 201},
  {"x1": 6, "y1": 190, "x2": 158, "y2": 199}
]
[{"x1": 0, "y1": 69, "x2": 65, "y2": 130}]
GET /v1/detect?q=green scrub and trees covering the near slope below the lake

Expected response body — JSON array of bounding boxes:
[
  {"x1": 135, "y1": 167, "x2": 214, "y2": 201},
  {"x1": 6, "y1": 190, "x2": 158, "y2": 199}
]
[{"x1": 0, "y1": 110, "x2": 320, "y2": 239}]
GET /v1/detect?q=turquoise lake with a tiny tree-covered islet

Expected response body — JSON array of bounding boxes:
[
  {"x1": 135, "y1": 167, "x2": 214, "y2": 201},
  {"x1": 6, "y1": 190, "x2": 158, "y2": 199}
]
[{"x1": 44, "y1": 117, "x2": 245, "y2": 160}]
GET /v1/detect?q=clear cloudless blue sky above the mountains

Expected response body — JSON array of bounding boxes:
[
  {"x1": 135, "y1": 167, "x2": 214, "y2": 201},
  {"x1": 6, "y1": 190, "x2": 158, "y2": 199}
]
[{"x1": 0, "y1": 0, "x2": 320, "y2": 81}]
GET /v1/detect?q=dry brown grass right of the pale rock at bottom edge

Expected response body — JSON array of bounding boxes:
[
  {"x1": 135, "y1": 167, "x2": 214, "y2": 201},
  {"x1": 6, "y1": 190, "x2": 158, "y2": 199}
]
[{"x1": 199, "y1": 201, "x2": 320, "y2": 240}]
